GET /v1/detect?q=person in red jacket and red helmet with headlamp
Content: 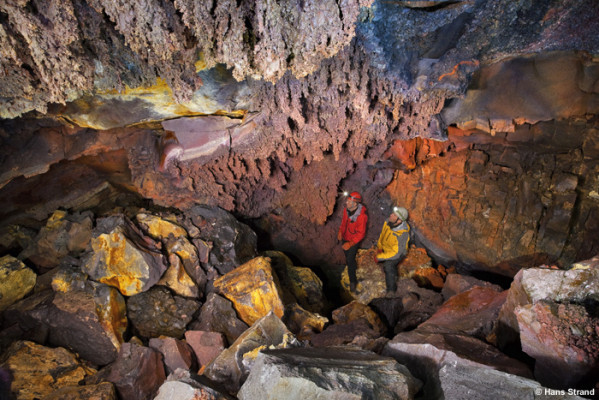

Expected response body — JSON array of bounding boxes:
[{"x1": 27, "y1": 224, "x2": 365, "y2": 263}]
[{"x1": 337, "y1": 192, "x2": 368, "y2": 292}]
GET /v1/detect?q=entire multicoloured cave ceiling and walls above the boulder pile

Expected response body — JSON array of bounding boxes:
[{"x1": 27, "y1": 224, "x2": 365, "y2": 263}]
[{"x1": 0, "y1": 0, "x2": 599, "y2": 274}]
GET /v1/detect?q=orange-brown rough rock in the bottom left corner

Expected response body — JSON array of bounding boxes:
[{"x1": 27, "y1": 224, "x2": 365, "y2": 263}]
[{"x1": 0, "y1": 341, "x2": 95, "y2": 400}]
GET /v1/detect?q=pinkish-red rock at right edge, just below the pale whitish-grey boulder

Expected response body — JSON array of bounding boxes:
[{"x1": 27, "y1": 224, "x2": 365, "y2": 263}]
[{"x1": 515, "y1": 300, "x2": 599, "y2": 389}]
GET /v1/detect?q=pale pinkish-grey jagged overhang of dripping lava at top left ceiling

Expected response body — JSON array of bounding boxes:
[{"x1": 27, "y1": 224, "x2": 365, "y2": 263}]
[{"x1": 0, "y1": 0, "x2": 372, "y2": 118}]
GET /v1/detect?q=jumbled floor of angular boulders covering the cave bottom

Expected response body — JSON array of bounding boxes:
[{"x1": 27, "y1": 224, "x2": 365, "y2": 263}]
[{"x1": 0, "y1": 197, "x2": 599, "y2": 400}]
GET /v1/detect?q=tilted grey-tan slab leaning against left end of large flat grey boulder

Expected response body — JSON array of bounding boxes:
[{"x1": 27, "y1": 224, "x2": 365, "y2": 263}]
[{"x1": 204, "y1": 312, "x2": 295, "y2": 392}]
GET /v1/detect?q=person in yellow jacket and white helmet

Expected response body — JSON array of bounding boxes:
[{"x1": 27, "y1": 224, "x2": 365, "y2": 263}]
[{"x1": 374, "y1": 207, "x2": 410, "y2": 294}]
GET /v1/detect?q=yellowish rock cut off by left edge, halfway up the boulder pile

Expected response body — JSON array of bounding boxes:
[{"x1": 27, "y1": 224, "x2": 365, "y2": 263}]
[{"x1": 0, "y1": 256, "x2": 37, "y2": 312}]
